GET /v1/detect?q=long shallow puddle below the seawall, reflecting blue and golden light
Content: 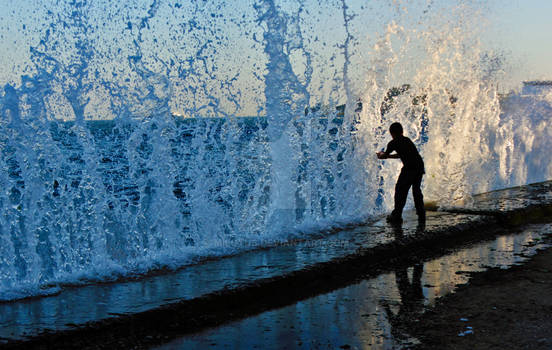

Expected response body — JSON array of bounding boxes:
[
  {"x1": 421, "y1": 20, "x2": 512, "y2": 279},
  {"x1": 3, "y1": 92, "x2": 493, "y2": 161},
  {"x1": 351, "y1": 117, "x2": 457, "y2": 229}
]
[{"x1": 155, "y1": 224, "x2": 552, "y2": 349}]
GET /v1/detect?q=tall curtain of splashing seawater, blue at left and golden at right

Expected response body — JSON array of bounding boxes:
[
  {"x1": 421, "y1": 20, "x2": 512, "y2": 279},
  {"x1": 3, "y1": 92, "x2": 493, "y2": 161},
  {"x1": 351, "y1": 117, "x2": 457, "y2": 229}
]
[{"x1": 0, "y1": 0, "x2": 552, "y2": 300}]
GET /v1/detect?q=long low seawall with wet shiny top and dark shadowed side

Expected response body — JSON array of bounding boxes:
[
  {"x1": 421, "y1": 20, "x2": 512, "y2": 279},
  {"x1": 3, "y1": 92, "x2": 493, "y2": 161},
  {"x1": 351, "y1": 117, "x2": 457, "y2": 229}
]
[{"x1": 0, "y1": 182, "x2": 552, "y2": 349}]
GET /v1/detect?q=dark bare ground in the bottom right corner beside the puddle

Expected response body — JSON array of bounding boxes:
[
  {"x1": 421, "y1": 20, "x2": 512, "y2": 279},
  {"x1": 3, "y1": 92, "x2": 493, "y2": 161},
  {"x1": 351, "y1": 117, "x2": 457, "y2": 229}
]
[{"x1": 409, "y1": 248, "x2": 552, "y2": 350}]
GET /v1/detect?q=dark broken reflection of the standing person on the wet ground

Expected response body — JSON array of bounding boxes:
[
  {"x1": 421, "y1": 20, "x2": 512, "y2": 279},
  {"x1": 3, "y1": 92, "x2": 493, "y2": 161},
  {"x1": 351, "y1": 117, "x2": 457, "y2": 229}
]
[{"x1": 382, "y1": 225, "x2": 424, "y2": 339}]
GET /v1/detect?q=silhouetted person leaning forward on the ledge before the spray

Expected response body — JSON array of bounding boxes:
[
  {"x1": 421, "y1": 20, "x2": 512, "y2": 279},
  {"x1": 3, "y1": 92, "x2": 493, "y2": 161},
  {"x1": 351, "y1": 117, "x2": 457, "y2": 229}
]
[{"x1": 377, "y1": 123, "x2": 425, "y2": 222}]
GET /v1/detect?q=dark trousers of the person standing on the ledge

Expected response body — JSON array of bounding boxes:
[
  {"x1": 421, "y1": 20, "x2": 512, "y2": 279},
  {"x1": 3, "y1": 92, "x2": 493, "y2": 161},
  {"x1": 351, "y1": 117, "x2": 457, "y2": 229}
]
[{"x1": 393, "y1": 168, "x2": 425, "y2": 217}]
